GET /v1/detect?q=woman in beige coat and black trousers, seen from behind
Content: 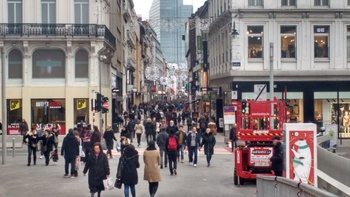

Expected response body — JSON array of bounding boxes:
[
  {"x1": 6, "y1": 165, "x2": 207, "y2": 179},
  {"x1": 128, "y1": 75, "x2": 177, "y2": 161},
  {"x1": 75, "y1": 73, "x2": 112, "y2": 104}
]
[{"x1": 143, "y1": 140, "x2": 161, "y2": 197}]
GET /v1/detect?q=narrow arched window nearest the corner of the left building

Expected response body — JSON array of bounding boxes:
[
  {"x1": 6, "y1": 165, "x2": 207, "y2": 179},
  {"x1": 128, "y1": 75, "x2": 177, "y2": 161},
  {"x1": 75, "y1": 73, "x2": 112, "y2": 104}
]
[{"x1": 75, "y1": 49, "x2": 89, "y2": 78}]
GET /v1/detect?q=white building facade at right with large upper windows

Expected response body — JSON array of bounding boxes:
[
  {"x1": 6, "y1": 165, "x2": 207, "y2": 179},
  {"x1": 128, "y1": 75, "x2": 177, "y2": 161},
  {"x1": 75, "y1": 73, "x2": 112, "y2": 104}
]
[{"x1": 209, "y1": 0, "x2": 350, "y2": 136}]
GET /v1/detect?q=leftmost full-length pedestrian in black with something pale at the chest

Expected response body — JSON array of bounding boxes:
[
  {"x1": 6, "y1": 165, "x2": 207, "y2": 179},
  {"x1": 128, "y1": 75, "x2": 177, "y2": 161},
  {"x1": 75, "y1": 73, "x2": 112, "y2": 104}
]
[{"x1": 23, "y1": 127, "x2": 39, "y2": 166}]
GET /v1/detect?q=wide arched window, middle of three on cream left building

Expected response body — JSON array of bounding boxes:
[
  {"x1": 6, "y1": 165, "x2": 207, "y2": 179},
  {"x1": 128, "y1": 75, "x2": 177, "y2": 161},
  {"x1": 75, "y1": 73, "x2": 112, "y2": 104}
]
[{"x1": 32, "y1": 49, "x2": 66, "y2": 79}]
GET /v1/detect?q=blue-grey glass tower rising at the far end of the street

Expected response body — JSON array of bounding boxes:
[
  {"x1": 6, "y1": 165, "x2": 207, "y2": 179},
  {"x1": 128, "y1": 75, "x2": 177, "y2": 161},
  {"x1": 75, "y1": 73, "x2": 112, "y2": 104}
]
[{"x1": 149, "y1": 0, "x2": 193, "y2": 63}]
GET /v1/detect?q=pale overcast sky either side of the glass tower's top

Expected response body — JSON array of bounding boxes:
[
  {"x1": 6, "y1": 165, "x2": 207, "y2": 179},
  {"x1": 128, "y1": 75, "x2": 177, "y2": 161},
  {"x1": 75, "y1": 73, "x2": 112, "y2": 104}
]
[{"x1": 134, "y1": 0, "x2": 205, "y2": 19}]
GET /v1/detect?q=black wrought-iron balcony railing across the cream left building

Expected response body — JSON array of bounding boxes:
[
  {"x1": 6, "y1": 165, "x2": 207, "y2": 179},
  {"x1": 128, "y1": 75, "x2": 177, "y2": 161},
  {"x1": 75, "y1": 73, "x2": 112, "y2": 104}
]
[{"x1": 0, "y1": 23, "x2": 116, "y2": 48}]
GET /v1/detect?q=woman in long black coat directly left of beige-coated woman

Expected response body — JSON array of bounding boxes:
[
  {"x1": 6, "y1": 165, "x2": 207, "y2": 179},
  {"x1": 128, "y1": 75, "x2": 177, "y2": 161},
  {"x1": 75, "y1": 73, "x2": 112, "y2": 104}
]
[{"x1": 117, "y1": 144, "x2": 140, "y2": 197}]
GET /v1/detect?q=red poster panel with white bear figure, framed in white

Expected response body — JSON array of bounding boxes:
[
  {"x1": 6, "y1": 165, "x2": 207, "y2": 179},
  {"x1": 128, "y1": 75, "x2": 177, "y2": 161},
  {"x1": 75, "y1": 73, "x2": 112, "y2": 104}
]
[{"x1": 283, "y1": 123, "x2": 317, "y2": 186}]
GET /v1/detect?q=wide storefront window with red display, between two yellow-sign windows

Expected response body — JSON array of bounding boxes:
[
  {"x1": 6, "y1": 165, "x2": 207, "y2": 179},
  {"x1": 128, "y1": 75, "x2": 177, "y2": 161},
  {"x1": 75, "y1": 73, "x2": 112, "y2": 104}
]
[{"x1": 31, "y1": 99, "x2": 66, "y2": 134}]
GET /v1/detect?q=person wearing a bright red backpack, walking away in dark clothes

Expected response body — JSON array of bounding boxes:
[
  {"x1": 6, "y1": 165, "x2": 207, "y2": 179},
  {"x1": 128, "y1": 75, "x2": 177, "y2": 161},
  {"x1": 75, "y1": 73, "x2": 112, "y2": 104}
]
[{"x1": 165, "y1": 131, "x2": 179, "y2": 175}]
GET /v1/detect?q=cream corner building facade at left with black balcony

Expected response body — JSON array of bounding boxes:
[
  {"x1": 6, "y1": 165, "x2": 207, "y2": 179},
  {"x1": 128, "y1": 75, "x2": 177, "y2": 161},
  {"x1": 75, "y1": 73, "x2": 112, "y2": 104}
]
[{"x1": 0, "y1": 0, "x2": 116, "y2": 134}]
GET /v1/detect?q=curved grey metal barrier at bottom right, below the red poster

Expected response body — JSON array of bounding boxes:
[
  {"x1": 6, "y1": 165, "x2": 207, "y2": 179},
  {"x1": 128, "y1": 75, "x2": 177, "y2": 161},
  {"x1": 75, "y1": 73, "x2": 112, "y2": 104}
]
[{"x1": 256, "y1": 176, "x2": 339, "y2": 197}]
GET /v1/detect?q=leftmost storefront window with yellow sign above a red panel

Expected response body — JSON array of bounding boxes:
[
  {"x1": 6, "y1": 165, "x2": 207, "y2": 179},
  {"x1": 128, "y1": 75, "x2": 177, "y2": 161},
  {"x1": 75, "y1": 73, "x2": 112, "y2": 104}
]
[{"x1": 7, "y1": 99, "x2": 22, "y2": 135}]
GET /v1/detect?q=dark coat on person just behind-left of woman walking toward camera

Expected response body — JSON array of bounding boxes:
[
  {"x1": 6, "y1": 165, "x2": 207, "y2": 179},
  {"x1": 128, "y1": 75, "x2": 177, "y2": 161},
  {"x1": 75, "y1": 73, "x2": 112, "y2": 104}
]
[{"x1": 61, "y1": 133, "x2": 80, "y2": 158}]
